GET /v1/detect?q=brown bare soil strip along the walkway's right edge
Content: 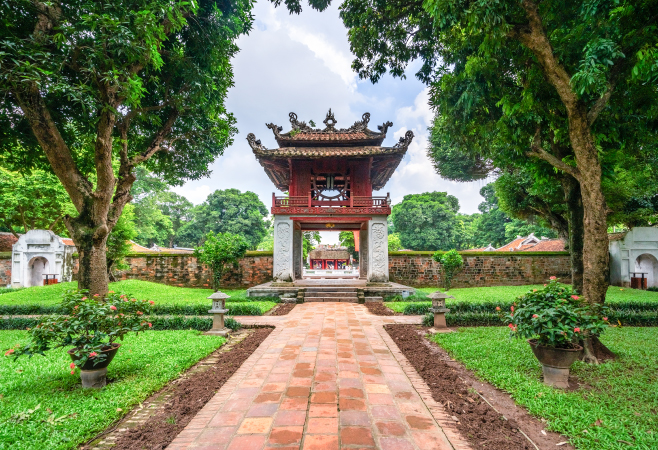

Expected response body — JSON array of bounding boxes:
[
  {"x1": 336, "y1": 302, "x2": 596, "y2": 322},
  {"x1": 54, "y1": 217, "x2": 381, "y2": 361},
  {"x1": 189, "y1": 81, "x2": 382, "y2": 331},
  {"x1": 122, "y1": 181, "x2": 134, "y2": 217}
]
[{"x1": 384, "y1": 325, "x2": 573, "y2": 450}]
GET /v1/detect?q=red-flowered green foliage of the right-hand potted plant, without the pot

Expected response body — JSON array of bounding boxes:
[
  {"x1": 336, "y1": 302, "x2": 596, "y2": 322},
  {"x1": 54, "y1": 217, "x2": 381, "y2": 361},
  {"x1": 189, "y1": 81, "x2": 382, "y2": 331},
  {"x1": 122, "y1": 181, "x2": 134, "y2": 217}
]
[{"x1": 501, "y1": 277, "x2": 608, "y2": 348}]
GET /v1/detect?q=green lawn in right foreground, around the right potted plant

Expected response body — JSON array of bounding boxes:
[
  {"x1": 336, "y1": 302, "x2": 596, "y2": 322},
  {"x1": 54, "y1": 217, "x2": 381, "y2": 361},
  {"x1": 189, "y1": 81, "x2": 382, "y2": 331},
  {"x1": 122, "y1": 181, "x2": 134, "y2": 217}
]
[{"x1": 432, "y1": 327, "x2": 658, "y2": 450}]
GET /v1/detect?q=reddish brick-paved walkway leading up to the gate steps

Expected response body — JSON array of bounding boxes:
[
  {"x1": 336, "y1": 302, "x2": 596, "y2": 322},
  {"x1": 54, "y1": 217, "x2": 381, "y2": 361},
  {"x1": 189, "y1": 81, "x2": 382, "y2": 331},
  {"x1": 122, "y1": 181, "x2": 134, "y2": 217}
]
[{"x1": 168, "y1": 303, "x2": 469, "y2": 450}]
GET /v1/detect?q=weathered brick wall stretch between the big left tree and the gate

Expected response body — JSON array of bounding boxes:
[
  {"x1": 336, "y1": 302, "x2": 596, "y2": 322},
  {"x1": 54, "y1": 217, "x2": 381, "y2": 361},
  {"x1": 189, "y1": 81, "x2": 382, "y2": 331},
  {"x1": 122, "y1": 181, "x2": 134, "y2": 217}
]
[{"x1": 117, "y1": 253, "x2": 273, "y2": 288}]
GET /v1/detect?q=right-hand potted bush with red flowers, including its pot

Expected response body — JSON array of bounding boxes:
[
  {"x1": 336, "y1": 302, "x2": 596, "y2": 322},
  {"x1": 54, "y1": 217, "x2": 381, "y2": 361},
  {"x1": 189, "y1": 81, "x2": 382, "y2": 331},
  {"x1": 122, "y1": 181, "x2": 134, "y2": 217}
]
[{"x1": 496, "y1": 277, "x2": 608, "y2": 389}]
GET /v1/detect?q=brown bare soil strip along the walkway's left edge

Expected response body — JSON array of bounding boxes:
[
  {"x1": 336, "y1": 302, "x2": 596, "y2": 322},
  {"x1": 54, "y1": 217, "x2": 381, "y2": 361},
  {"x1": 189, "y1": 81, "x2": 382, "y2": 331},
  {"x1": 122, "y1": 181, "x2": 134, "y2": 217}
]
[{"x1": 85, "y1": 327, "x2": 273, "y2": 450}]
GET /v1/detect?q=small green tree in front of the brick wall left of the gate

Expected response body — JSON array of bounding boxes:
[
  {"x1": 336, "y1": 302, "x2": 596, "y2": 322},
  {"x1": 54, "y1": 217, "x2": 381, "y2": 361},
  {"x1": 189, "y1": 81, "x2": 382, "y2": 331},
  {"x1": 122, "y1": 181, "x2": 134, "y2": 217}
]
[{"x1": 194, "y1": 231, "x2": 249, "y2": 290}]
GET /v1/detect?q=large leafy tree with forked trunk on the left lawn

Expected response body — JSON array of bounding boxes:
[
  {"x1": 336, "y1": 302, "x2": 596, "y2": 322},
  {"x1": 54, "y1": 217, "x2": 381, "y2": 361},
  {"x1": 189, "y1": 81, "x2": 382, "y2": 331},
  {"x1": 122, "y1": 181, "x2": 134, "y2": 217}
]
[{"x1": 0, "y1": 0, "x2": 252, "y2": 294}]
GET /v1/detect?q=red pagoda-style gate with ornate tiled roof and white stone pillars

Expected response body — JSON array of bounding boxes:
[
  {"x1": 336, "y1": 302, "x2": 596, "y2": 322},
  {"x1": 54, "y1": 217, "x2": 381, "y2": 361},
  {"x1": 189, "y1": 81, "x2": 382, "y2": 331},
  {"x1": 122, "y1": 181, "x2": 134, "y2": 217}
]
[{"x1": 247, "y1": 110, "x2": 413, "y2": 282}]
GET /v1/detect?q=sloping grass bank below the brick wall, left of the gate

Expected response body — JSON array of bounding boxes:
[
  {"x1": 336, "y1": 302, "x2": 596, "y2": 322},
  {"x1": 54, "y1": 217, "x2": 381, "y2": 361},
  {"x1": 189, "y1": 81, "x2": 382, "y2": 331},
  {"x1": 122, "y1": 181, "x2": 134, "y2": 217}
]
[{"x1": 0, "y1": 280, "x2": 276, "y2": 314}]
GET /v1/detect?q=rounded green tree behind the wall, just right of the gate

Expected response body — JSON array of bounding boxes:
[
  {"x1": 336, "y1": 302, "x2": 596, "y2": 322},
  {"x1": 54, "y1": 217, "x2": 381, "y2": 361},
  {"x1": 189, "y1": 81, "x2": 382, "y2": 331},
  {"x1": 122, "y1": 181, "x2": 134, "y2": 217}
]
[{"x1": 392, "y1": 192, "x2": 459, "y2": 250}]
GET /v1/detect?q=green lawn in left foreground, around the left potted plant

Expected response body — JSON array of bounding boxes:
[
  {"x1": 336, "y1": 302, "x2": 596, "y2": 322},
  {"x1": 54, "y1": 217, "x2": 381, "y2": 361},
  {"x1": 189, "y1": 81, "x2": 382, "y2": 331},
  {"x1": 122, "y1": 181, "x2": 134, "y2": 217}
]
[{"x1": 0, "y1": 330, "x2": 225, "y2": 450}]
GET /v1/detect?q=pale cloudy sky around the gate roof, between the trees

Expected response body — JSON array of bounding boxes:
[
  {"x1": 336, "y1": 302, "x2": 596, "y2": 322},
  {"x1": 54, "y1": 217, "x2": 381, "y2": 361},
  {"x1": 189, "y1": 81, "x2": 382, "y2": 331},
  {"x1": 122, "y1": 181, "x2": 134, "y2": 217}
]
[{"x1": 173, "y1": 0, "x2": 485, "y2": 244}]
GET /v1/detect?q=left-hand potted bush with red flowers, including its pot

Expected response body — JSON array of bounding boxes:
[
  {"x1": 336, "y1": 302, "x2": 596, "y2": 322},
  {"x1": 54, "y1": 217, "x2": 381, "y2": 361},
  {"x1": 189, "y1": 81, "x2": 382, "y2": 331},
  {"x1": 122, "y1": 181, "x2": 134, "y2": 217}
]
[{"x1": 8, "y1": 290, "x2": 153, "y2": 389}]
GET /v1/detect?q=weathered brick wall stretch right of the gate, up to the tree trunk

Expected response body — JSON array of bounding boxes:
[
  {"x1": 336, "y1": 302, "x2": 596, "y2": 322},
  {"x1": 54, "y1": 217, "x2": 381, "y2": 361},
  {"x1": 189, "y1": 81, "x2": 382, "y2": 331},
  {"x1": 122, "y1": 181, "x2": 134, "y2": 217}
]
[{"x1": 388, "y1": 252, "x2": 571, "y2": 287}]
